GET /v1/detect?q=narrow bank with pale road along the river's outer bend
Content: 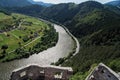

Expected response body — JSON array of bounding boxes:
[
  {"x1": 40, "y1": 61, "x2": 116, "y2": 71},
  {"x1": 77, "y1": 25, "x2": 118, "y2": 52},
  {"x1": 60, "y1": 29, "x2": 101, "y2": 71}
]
[{"x1": 40, "y1": 18, "x2": 80, "y2": 66}]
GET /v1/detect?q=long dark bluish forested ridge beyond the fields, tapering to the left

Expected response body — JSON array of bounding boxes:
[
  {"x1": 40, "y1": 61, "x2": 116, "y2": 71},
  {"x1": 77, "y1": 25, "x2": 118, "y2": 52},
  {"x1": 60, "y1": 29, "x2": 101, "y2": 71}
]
[{"x1": 9, "y1": 3, "x2": 79, "y2": 23}]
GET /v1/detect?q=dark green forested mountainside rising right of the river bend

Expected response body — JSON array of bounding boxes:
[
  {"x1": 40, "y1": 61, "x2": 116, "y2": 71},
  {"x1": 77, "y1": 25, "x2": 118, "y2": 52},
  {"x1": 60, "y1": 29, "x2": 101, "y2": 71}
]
[{"x1": 62, "y1": 2, "x2": 120, "y2": 80}]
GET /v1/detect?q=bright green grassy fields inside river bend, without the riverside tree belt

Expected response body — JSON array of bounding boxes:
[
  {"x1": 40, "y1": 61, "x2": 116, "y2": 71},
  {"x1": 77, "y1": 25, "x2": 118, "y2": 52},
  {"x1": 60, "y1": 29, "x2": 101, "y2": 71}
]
[{"x1": 0, "y1": 13, "x2": 58, "y2": 62}]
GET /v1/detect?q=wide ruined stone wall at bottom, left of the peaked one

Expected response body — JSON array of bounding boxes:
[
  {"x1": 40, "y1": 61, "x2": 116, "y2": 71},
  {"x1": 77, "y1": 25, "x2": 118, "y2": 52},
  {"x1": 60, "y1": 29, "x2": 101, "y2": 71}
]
[{"x1": 10, "y1": 65, "x2": 73, "y2": 80}]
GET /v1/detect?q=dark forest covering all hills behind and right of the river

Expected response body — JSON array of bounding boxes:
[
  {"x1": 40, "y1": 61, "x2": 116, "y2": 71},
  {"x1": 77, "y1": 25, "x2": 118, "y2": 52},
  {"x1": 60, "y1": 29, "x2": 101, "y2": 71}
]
[{"x1": 0, "y1": 1, "x2": 120, "y2": 80}]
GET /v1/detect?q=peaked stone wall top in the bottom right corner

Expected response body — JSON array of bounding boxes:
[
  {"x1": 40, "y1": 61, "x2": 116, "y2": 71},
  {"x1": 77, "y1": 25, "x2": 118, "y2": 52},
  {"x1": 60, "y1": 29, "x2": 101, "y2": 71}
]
[{"x1": 86, "y1": 63, "x2": 120, "y2": 80}]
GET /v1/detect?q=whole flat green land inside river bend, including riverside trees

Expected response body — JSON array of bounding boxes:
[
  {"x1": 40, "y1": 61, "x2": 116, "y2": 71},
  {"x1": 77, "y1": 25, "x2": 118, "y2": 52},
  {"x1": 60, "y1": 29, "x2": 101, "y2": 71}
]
[{"x1": 0, "y1": 11, "x2": 58, "y2": 62}]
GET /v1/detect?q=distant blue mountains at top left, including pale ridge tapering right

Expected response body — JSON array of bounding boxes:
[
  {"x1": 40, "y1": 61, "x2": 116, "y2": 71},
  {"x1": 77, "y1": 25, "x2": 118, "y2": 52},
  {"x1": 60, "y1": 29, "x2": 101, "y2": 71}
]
[{"x1": 0, "y1": 0, "x2": 53, "y2": 8}]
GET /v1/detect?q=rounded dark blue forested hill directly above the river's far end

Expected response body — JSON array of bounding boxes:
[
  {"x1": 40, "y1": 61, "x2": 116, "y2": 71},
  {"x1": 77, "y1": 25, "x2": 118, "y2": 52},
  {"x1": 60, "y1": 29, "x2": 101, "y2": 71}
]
[{"x1": 41, "y1": 3, "x2": 79, "y2": 23}]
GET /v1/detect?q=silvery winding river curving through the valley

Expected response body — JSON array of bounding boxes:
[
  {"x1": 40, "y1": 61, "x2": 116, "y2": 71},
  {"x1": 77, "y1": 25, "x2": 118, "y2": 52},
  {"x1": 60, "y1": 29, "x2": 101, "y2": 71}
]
[{"x1": 0, "y1": 24, "x2": 79, "y2": 80}]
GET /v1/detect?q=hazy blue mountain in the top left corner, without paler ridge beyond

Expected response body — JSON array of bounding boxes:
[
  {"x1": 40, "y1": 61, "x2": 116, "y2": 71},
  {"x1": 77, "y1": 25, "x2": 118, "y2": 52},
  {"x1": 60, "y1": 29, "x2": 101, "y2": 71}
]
[{"x1": 0, "y1": 0, "x2": 31, "y2": 7}]
